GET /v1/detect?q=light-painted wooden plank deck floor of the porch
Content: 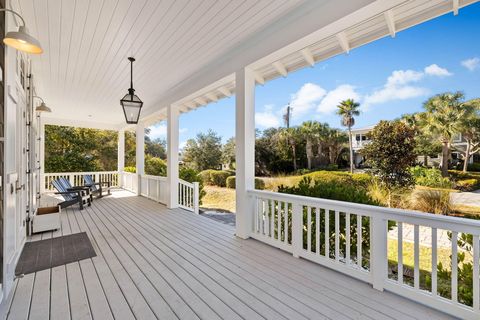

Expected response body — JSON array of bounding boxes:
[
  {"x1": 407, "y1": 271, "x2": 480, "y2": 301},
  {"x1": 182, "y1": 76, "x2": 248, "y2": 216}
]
[{"x1": 8, "y1": 191, "x2": 456, "y2": 320}]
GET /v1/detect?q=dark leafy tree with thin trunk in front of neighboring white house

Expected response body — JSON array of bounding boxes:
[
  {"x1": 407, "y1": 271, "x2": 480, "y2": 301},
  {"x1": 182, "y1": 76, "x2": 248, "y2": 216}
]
[{"x1": 362, "y1": 121, "x2": 416, "y2": 206}]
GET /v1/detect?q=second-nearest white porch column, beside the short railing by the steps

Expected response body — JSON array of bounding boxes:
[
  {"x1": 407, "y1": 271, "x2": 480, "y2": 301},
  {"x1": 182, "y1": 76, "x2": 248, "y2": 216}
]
[{"x1": 167, "y1": 105, "x2": 179, "y2": 208}]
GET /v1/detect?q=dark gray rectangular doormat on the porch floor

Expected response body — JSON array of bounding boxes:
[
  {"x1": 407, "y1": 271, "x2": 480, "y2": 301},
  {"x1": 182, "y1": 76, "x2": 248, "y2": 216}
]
[{"x1": 15, "y1": 232, "x2": 97, "y2": 276}]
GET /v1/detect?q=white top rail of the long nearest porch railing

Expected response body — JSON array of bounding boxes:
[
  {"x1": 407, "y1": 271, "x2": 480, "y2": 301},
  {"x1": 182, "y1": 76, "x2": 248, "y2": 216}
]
[{"x1": 248, "y1": 190, "x2": 480, "y2": 234}]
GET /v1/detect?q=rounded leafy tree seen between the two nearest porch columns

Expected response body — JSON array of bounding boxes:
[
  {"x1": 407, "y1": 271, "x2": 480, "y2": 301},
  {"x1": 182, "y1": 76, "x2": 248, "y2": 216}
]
[{"x1": 183, "y1": 129, "x2": 222, "y2": 171}]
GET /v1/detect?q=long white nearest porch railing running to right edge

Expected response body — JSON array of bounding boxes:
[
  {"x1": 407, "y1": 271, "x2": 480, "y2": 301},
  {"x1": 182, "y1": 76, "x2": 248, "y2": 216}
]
[{"x1": 249, "y1": 190, "x2": 480, "y2": 319}]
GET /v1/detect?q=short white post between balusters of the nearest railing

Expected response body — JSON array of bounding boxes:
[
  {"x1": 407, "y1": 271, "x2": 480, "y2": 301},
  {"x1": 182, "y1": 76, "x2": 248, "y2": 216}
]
[{"x1": 370, "y1": 216, "x2": 388, "y2": 291}]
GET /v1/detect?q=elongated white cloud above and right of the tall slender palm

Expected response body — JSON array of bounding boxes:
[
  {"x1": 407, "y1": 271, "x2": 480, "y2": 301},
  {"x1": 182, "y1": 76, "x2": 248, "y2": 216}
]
[{"x1": 362, "y1": 68, "x2": 428, "y2": 110}]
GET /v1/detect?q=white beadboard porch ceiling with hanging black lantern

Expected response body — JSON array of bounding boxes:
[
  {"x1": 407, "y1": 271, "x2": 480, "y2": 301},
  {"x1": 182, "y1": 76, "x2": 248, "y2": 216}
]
[{"x1": 10, "y1": 0, "x2": 303, "y2": 125}]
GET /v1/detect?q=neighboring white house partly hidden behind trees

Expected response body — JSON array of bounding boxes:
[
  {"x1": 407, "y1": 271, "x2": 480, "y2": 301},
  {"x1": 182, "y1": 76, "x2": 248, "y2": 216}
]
[{"x1": 352, "y1": 125, "x2": 480, "y2": 168}]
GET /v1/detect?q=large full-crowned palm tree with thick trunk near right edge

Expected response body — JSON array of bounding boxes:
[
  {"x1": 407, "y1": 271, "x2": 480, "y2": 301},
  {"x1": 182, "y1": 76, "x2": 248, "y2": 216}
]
[{"x1": 420, "y1": 91, "x2": 474, "y2": 177}]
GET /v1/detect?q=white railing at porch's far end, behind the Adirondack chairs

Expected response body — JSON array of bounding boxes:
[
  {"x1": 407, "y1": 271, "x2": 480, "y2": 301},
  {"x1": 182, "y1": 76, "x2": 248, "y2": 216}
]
[{"x1": 40, "y1": 171, "x2": 118, "y2": 192}]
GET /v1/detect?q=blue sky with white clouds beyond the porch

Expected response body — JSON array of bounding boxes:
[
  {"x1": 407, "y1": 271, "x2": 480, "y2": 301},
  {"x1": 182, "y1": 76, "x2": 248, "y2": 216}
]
[{"x1": 150, "y1": 3, "x2": 480, "y2": 146}]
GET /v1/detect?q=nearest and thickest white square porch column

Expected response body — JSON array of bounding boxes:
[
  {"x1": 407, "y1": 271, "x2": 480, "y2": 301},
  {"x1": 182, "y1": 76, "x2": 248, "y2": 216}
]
[{"x1": 235, "y1": 69, "x2": 255, "y2": 239}]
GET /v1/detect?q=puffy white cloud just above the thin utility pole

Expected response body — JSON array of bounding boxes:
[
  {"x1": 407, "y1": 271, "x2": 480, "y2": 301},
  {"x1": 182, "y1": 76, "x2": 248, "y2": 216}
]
[{"x1": 290, "y1": 82, "x2": 327, "y2": 118}]
